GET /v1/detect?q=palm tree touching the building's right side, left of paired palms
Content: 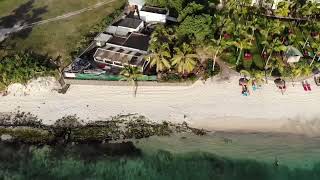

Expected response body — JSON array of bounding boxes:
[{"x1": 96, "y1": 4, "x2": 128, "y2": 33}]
[{"x1": 146, "y1": 40, "x2": 171, "y2": 72}]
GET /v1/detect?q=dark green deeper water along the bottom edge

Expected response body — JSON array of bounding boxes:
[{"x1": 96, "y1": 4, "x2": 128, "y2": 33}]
[{"x1": 0, "y1": 145, "x2": 320, "y2": 180}]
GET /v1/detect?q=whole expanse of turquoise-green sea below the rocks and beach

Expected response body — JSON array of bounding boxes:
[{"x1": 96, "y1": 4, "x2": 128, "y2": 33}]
[{"x1": 0, "y1": 132, "x2": 320, "y2": 180}]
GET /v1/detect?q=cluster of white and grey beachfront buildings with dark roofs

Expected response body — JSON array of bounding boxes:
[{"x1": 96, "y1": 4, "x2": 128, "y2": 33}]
[{"x1": 64, "y1": 0, "x2": 174, "y2": 79}]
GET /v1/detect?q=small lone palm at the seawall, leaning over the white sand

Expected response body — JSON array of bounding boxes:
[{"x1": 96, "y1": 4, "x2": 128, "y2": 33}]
[{"x1": 120, "y1": 66, "x2": 143, "y2": 97}]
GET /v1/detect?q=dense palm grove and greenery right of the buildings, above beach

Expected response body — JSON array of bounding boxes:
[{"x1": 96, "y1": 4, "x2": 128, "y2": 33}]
[{"x1": 147, "y1": 0, "x2": 320, "y2": 78}]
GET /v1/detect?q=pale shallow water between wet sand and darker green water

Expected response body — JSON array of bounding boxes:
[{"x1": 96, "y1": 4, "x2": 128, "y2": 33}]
[{"x1": 133, "y1": 132, "x2": 320, "y2": 169}]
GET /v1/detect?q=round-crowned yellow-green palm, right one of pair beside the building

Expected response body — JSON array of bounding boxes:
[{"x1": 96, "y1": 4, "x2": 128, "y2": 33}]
[{"x1": 172, "y1": 43, "x2": 198, "y2": 74}]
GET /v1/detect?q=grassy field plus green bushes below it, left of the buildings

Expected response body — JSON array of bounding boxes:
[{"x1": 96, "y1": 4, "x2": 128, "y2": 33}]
[{"x1": 0, "y1": 0, "x2": 125, "y2": 91}]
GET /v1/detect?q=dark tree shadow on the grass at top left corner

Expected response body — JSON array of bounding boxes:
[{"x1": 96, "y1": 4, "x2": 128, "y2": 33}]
[{"x1": 0, "y1": 0, "x2": 48, "y2": 39}]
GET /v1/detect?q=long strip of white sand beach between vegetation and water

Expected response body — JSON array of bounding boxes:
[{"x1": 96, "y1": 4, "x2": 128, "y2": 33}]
[{"x1": 0, "y1": 77, "x2": 320, "y2": 136}]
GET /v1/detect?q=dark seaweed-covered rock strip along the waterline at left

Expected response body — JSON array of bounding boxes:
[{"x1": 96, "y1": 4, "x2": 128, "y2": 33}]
[{"x1": 0, "y1": 113, "x2": 207, "y2": 145}]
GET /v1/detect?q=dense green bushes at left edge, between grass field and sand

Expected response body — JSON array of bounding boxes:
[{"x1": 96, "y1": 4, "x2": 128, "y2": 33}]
[{"x1": 0, "y1": 52, "x2": 59, "y2": 91}]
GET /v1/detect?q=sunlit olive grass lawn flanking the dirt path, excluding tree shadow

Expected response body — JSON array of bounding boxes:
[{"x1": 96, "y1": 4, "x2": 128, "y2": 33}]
[{"x1": 0, "y1": 0, "x2": 125, "y2": 63}]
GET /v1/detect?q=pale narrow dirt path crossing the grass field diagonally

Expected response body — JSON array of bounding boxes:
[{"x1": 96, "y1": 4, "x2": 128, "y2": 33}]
[{"x1": 0, "y1": 0, "x2": 115, "y2": 42}]
